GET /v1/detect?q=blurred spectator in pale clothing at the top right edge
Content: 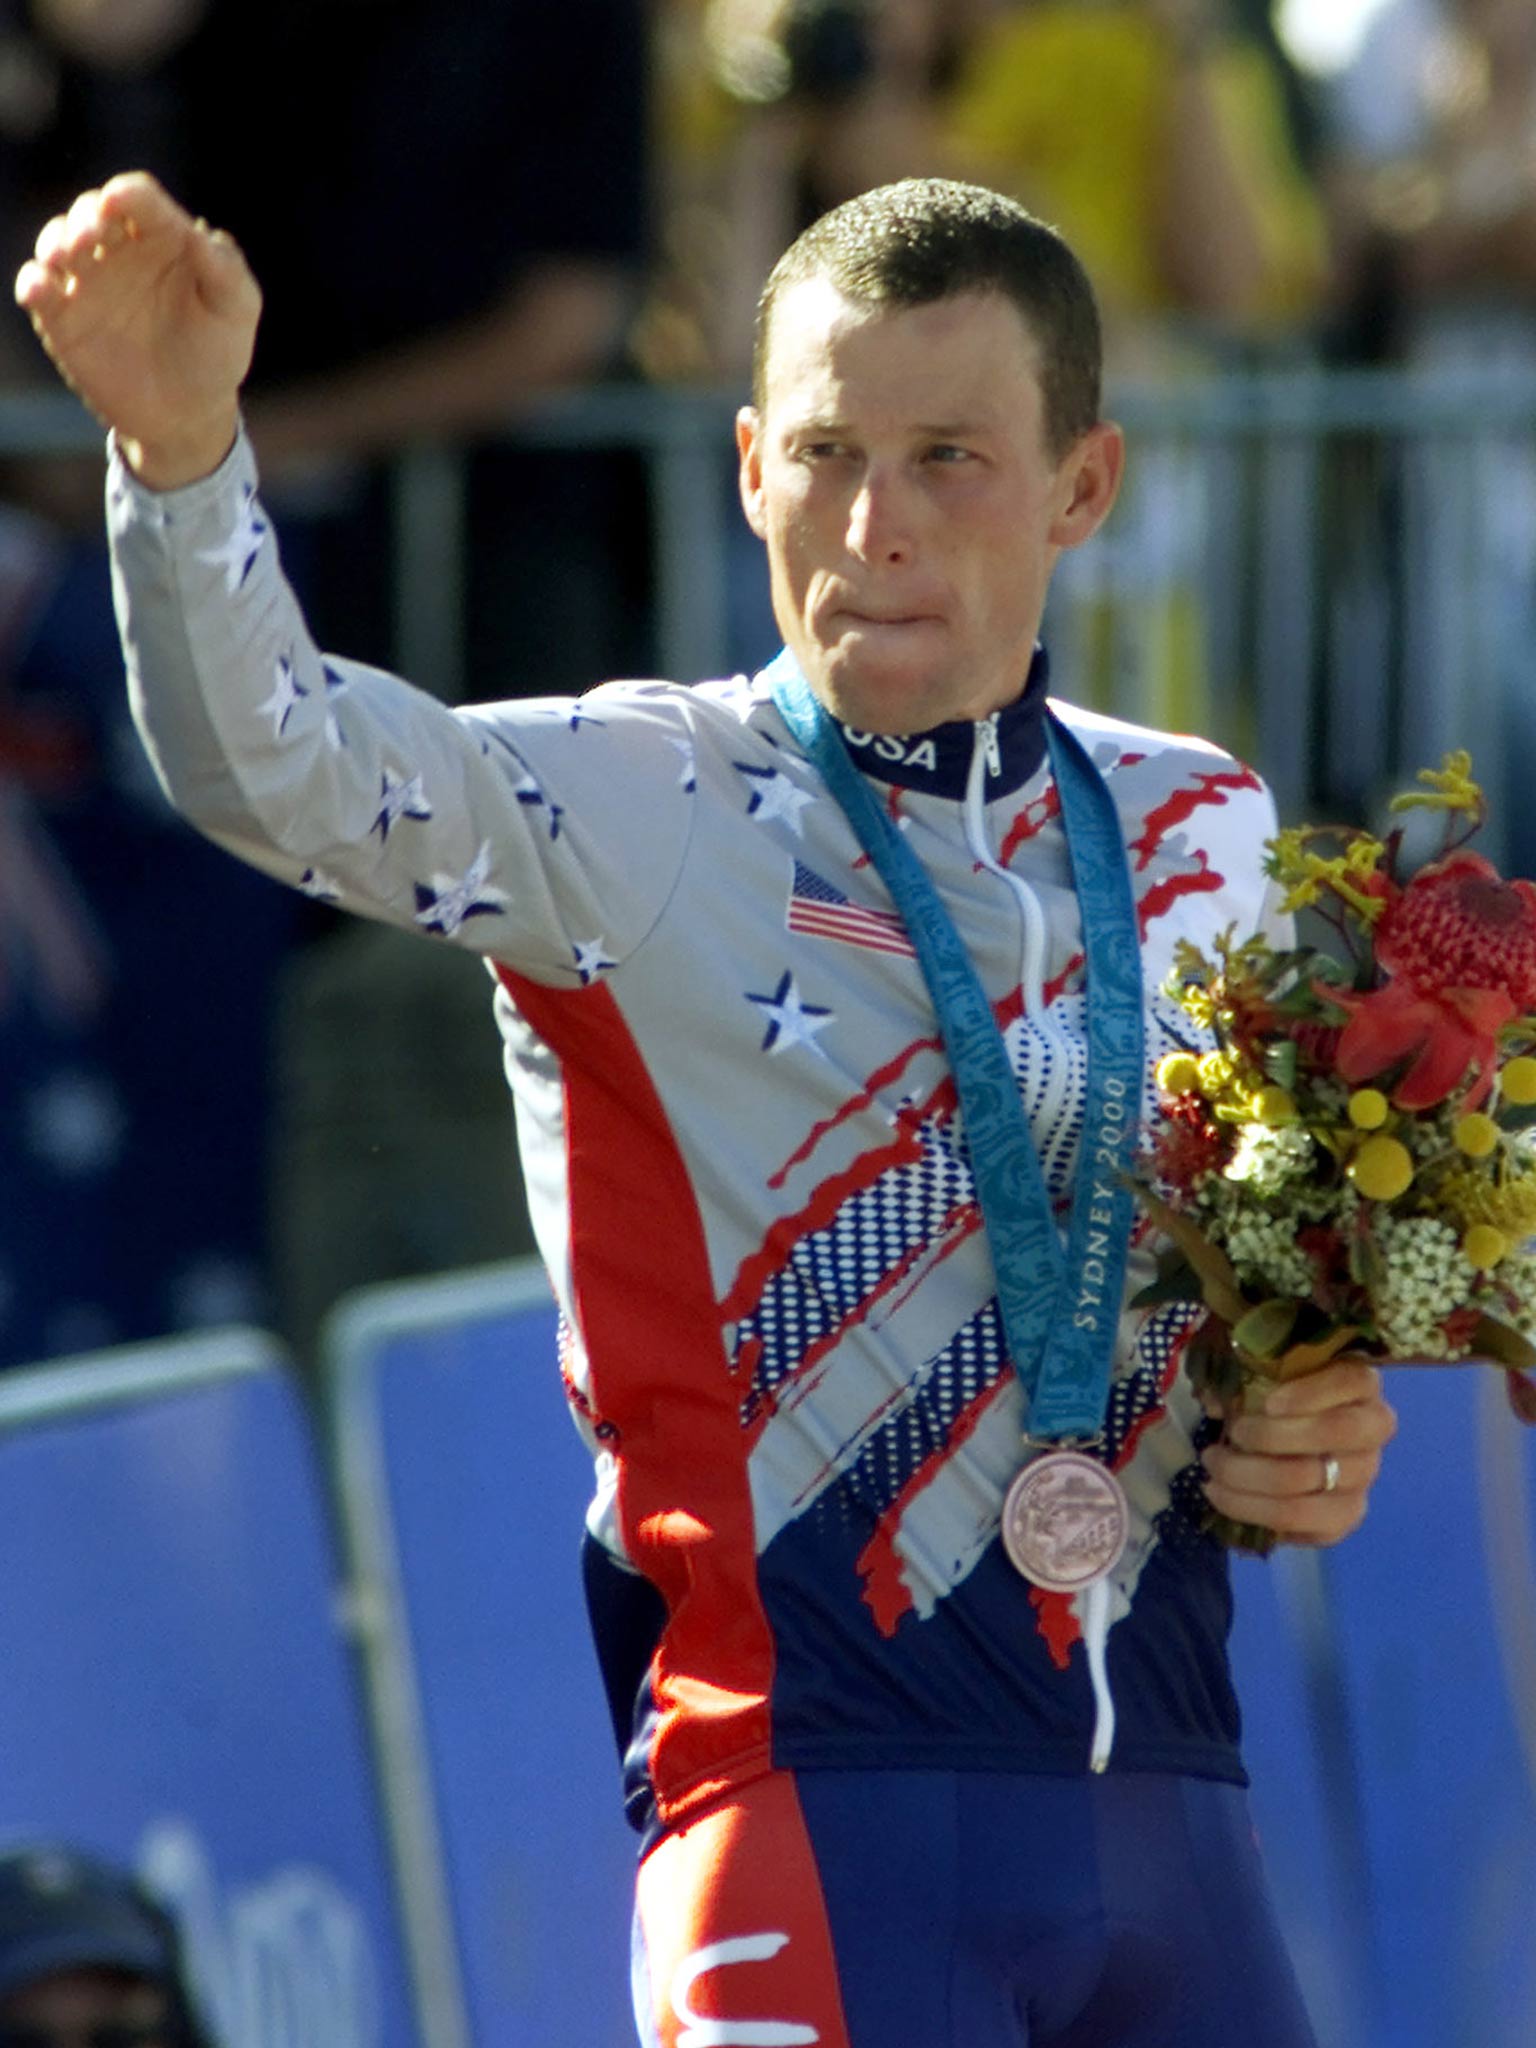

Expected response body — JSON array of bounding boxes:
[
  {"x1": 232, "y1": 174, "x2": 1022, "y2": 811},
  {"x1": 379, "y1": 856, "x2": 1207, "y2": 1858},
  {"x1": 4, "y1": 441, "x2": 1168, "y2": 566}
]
[{"x1": 1331, "y1": 0, "x2": 1536, "y2": 872}]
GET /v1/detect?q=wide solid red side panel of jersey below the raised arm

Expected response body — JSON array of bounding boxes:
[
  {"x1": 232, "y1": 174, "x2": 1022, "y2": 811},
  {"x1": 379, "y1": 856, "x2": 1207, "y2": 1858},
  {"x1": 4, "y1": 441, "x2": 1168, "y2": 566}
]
[{"x1": 498, "y1": 967, "x2": 774, "y2": 1825}]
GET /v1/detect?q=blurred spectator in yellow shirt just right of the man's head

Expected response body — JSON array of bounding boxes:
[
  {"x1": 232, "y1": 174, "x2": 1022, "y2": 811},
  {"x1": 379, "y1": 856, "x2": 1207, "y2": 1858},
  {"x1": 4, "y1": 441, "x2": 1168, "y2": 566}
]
[{"x1": 944, "y1": 0, "x2": 1327, "y2": 743}]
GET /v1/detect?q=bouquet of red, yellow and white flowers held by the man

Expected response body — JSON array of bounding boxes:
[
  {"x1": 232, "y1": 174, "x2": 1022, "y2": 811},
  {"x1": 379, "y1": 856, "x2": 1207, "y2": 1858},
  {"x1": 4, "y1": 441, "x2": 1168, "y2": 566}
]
[{"x1": 1135, "y1": 754, "x2": 1536, "y2": 1550}]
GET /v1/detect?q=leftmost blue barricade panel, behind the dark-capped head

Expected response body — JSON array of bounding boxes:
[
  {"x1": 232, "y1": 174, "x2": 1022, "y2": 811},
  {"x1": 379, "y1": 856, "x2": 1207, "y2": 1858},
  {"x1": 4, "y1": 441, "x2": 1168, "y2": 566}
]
[{"x1": 0, "y1": 1333, "x2": 420, "y2": 2048}]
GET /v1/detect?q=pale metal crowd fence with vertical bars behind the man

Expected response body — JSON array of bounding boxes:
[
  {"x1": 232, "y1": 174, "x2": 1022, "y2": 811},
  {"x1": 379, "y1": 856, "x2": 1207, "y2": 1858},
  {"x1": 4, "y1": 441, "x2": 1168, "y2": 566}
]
[{"x1": 18, "y1": 369, "x2": 1536, "y2": 843}]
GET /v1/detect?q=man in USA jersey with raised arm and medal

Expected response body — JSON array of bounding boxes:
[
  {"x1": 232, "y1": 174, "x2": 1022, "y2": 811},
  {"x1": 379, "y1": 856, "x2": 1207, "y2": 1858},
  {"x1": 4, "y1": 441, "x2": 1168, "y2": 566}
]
[{"x1": 18, "y1": 176, "x2": 1393, "y2": 2048}]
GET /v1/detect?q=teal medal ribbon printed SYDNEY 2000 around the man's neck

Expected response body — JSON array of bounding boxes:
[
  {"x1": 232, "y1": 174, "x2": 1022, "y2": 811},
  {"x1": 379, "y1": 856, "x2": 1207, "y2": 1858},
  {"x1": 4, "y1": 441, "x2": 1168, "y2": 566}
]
[{"x1": 768, "y1": 653, "x2": 1145, "y2": 1442}]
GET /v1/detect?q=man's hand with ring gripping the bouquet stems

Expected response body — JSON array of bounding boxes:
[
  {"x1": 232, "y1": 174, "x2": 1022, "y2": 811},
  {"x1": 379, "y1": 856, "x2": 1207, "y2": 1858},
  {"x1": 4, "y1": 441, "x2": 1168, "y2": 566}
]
[{"x1": 1202, "y1": 1358, "x2": 1397, "y2": 1544}]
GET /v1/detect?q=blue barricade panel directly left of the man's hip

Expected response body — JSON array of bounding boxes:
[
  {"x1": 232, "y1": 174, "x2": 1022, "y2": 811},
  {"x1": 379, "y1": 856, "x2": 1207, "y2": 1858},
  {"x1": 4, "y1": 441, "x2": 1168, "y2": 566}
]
[{"x1": 328, "y1": 1264, "x2": 635, "y2": 2048}]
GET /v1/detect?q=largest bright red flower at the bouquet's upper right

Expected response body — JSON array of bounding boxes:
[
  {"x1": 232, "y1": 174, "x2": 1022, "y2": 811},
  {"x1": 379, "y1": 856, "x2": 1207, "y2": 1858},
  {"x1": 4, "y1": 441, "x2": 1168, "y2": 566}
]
[{"x1": 1321, "y1": 852, "x2": 1536, "y2": 1110}]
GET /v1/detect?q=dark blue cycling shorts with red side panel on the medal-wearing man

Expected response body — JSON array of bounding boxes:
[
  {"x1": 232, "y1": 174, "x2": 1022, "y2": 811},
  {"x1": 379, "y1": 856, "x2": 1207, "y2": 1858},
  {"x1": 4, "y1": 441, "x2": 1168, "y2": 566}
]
[{"x1": 635, "y1": 1772, "x2": 1315, "y2": 2048}]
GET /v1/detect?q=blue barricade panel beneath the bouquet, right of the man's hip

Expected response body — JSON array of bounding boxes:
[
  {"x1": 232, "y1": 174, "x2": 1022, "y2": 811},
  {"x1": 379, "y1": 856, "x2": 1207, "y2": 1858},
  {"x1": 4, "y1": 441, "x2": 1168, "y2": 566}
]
[{"x1": 1235, "y1": 1368, "x2": 1536, "y2": 2048}]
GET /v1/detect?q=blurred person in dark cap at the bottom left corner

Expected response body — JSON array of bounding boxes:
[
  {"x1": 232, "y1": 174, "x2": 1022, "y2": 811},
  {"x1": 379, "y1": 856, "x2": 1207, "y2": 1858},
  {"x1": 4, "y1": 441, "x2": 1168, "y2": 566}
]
[{"x1": 0, "y1": 1845, "x2": 211, "y2": 2048}]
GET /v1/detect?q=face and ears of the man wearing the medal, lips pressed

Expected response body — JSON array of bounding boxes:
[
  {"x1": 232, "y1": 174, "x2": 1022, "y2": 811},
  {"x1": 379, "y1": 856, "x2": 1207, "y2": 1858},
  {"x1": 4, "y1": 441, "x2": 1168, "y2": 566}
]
[{"x1": 737, "y1": 276, "x2": 1122, "y2": 733}]
